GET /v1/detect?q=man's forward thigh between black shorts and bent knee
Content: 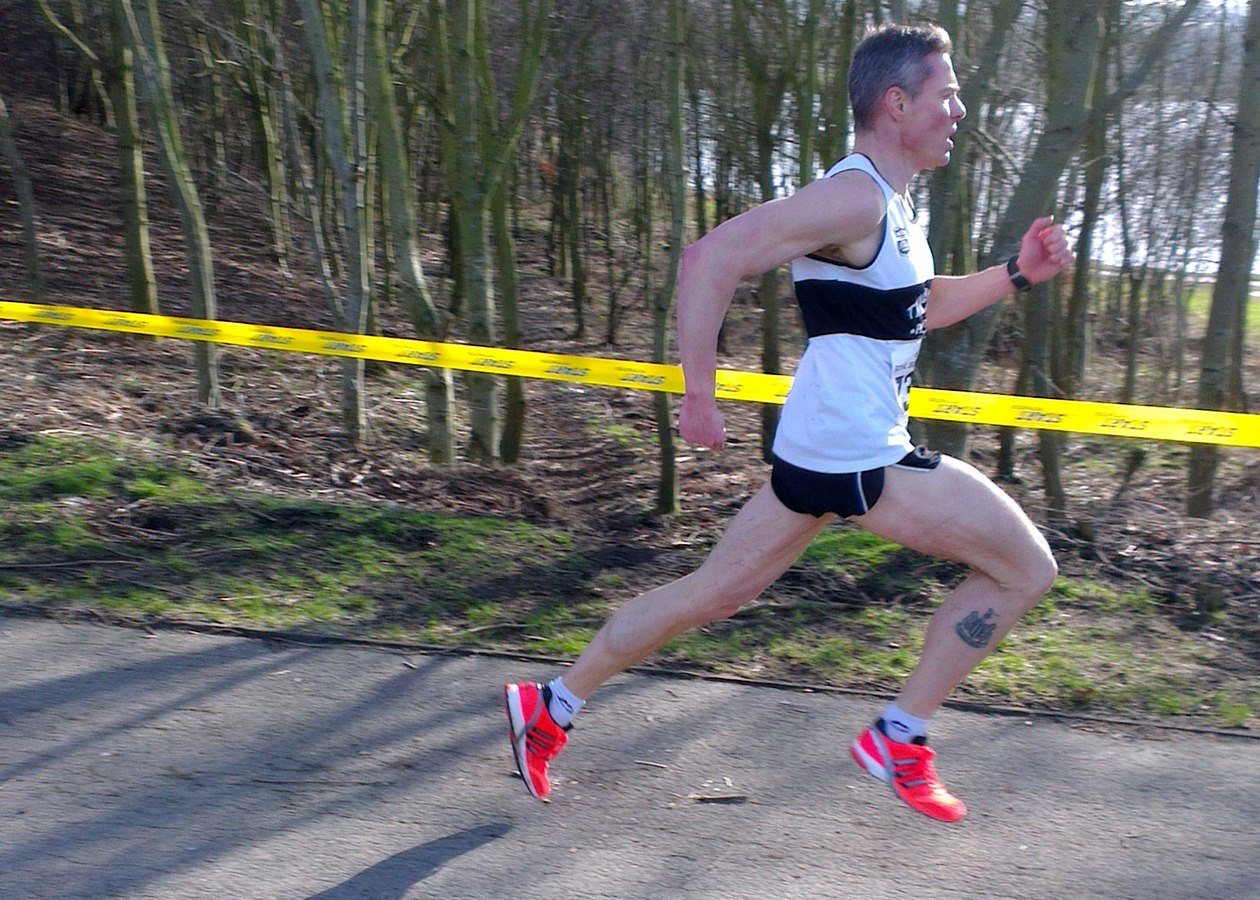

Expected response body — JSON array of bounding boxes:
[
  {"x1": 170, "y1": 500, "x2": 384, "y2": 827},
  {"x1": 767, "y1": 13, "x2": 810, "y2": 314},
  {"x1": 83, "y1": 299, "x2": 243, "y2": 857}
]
[{"x1": 853, "y1": 456, "x2": 1050, "y2": 575}]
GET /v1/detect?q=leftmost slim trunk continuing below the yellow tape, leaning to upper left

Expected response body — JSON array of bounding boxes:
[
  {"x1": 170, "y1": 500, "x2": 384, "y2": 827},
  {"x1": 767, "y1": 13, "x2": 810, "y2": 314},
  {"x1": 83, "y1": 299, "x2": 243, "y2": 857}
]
[{"x1": 120, "y1": 0, "x2": 219, "y2": 408}]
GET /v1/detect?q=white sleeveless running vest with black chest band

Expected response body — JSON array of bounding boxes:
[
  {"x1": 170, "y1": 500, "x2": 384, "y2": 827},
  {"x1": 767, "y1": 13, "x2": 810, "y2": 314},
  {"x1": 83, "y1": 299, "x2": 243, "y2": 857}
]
[{"x1": 774, "y1": 154, "x2": 934, "y2": 473}]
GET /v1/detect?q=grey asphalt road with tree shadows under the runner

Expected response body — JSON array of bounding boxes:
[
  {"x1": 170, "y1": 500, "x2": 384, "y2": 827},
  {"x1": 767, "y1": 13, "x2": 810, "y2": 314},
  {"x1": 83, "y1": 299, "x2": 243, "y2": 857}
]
[{"x1": 0, "y1": 616, "x2": 1260, "y2": 900}]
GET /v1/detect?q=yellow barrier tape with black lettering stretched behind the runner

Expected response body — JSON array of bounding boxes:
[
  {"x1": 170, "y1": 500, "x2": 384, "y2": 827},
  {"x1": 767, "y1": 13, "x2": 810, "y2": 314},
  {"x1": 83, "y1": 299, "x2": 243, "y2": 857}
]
[{"x1": 0, "y1": 300, "x2": 1260, "y2": 447}]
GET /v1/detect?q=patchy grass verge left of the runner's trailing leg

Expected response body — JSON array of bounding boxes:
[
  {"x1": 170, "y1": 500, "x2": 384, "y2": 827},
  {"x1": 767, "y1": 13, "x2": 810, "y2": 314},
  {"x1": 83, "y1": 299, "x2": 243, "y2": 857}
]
[{"x1": 0, "y1": 437, "x2": 583, "y2": 639}]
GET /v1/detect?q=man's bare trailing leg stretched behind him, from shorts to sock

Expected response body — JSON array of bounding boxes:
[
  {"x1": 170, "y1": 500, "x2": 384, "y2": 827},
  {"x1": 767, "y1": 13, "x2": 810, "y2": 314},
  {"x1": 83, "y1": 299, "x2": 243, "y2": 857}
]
[{"x1": 563, "y1": 483, "x2": 834, "y2": 700}]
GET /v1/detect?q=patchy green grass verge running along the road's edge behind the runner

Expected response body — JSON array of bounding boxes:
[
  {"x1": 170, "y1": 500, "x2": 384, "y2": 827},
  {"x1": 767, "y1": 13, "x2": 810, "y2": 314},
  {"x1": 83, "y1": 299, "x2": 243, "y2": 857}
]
[{"x1": 0, "y1": 428, "x2": 1260, "y2": 727}]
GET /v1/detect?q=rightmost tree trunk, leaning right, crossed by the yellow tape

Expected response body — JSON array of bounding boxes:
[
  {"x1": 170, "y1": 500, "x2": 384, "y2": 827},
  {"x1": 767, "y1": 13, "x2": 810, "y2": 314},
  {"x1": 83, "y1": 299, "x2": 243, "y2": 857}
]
[{"x1": 1186, "y1": 4, "x2": 1260, "y2": 518}]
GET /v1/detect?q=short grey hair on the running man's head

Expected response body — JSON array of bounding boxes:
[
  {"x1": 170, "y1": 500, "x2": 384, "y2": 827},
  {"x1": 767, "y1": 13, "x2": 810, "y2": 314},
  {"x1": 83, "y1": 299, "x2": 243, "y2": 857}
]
[{"x1": 849, "y1": 25, "x2": 954, "y2": 131}]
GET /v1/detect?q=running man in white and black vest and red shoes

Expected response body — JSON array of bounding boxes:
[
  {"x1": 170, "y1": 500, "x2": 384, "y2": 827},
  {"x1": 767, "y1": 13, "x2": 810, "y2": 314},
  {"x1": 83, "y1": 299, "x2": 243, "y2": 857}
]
[{"x1": 504, "y1": 25, "x2": 1072, "y2": 822}]
